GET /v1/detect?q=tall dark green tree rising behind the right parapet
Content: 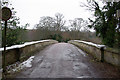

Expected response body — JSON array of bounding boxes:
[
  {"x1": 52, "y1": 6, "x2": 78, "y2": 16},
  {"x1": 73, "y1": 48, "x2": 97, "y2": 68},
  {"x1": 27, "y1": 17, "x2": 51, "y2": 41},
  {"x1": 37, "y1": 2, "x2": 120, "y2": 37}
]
[{"x1": 82, "y1": 0, "x2": 120, "y2": 48}]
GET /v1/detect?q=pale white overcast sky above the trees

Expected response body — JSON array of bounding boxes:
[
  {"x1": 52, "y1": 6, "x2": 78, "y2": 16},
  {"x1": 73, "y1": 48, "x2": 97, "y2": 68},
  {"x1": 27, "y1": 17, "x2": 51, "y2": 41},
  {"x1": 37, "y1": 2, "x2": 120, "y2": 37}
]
[{"x1": 9, "y1": 0, "x2": 91, "y2": 29}]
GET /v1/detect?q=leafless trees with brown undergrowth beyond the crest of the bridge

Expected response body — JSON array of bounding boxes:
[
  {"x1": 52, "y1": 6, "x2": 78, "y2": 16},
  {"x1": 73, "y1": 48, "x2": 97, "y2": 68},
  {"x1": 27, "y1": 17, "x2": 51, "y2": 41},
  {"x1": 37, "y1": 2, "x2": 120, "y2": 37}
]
[{"x1": 28, "y1": 13, "x2": 100, "y2": 43}]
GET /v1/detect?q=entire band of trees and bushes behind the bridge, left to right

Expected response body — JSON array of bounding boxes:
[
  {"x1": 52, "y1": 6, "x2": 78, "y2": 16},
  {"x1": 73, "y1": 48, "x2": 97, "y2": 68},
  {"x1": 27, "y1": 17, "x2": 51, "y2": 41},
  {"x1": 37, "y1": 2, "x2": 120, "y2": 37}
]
[{"x1": 2, "y1": 0, "x2": 120, "y2": 48}]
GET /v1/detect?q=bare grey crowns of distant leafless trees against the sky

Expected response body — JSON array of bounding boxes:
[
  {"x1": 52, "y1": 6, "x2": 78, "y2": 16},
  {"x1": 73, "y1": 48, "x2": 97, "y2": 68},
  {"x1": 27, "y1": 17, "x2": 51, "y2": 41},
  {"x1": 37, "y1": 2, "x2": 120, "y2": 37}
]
[{"x1": 34, "y1": 13, "x2": 88, "y2": 31}]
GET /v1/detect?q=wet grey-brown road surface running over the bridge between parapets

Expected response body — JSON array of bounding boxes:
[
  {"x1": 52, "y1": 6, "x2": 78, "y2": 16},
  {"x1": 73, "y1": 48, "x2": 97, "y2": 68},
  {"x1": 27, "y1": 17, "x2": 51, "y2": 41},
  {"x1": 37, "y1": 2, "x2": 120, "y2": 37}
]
[{"x1": 16, "y1": 43, "x2": 120, "y2": 78}]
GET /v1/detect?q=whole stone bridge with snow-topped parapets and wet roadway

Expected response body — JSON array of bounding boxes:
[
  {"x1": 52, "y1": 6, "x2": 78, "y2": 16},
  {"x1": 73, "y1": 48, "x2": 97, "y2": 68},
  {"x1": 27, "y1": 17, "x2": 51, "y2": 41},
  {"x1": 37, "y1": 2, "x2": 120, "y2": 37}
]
[{"x1": 0, "y1": 40, "x2": 120, "y2": 80}]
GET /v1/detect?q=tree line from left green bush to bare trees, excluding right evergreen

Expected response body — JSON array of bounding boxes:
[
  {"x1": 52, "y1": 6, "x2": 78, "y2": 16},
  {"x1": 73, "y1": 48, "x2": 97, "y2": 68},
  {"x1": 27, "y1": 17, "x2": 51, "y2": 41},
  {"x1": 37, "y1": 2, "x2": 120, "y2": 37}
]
[{"x1": 1, "y1": 2, "x2": 106, "y2": 46}]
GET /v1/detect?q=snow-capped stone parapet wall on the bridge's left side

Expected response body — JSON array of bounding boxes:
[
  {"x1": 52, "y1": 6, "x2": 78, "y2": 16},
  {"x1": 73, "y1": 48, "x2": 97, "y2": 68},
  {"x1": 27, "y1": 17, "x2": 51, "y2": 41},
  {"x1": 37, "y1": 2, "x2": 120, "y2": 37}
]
[{"x1": 0, "y1": 40, "x2": 58, "y2": 66}]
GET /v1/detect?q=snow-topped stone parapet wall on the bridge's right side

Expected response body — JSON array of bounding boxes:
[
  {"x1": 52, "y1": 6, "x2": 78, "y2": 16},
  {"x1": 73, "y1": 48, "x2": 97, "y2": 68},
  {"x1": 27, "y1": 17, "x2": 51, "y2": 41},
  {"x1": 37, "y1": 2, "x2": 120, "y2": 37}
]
[{"x1": 68, "y1": 40, "x2": 120, "y2": 67}]
